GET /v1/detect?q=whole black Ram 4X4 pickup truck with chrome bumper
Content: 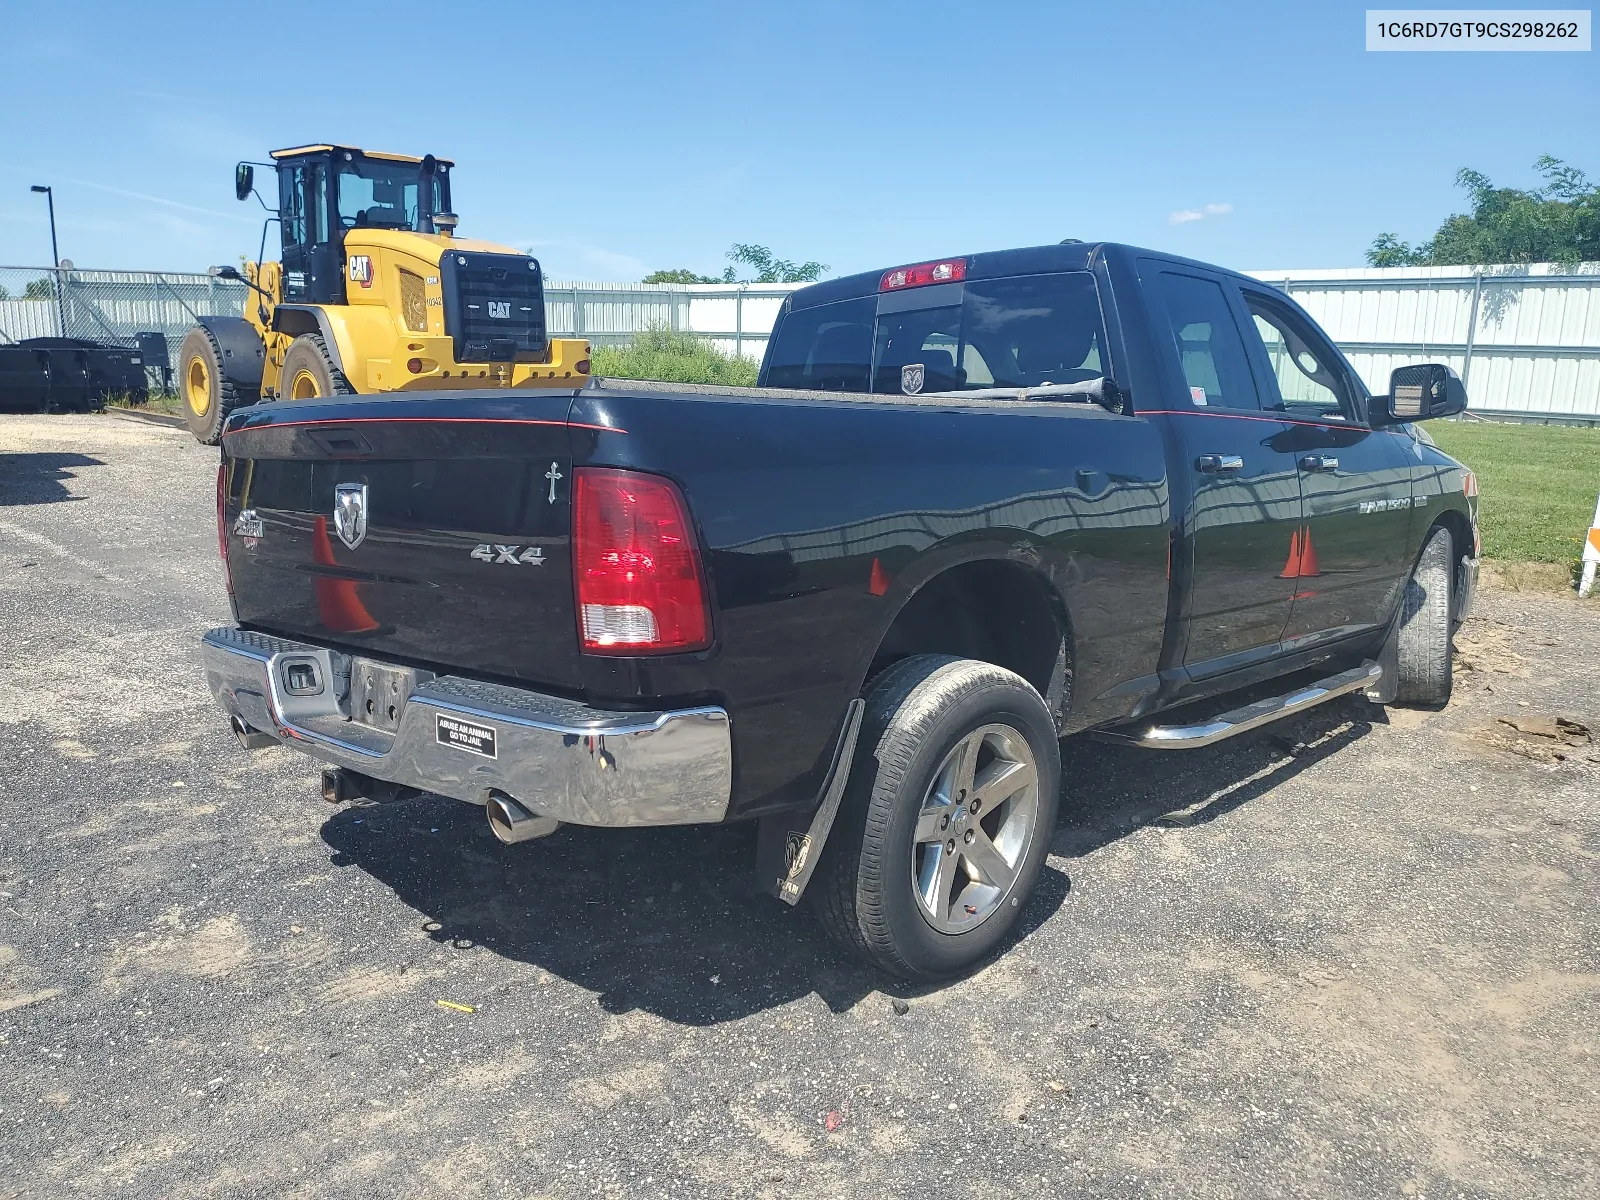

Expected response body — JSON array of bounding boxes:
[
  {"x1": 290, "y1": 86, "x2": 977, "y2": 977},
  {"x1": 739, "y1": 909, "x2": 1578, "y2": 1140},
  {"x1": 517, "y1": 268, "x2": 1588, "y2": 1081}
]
[{"x1": 203, "y1": 243, "x2": 1478, "y2": 978}]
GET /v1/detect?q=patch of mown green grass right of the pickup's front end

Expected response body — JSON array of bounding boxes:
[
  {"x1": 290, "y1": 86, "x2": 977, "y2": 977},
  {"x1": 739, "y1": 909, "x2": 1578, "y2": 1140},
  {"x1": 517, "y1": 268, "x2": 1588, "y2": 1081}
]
[{"x1": 1427, "y1": 421, "x2": 1600, "y2": 566}]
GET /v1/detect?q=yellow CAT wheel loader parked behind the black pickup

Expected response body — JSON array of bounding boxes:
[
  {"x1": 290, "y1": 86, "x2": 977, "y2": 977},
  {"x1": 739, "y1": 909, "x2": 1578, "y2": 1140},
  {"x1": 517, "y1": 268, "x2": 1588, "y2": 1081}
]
[{"x1": 178, "y1": 146, "x2": 589, "y2": 445}]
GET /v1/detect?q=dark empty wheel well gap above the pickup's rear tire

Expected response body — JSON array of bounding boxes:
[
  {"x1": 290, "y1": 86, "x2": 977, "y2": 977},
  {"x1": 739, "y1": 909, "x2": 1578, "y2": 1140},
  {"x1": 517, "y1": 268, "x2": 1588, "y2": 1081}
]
[{"x1": 869, "y1": 560, "x2": 1072, "y2": 723}]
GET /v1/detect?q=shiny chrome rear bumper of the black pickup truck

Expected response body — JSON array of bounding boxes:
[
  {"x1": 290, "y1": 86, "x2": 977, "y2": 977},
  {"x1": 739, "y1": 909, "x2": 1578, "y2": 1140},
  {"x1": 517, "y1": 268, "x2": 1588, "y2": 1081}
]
[{"x1": 202, "y1": 629, "x2": 733, "y2": 826}]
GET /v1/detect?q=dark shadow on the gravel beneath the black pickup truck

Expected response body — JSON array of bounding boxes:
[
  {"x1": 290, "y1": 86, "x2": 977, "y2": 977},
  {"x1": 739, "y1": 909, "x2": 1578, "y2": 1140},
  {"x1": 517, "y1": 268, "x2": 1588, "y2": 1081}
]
[{"x1": 322, "y1": 702, "x2": 1381, "y2": 1026}]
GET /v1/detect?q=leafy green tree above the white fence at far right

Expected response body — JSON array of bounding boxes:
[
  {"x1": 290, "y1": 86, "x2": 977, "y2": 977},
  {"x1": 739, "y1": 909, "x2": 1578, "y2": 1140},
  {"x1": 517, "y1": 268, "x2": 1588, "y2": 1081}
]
[{"x1": 1366, "y1": 154, "x2": 1600, "y2": 267}]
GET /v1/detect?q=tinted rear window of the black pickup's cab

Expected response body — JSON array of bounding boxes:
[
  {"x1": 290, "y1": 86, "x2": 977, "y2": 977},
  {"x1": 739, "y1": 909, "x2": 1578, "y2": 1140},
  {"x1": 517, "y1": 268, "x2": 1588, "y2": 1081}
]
[{"x1": 763, "y1": 270, "x2": 1107, "y2": 394}]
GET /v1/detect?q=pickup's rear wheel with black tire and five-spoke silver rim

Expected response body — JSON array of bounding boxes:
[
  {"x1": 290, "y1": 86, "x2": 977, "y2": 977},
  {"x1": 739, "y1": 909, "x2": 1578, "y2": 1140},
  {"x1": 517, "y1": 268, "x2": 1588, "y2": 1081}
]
[{"x1": 811, "y1": 654, "x2": 1061, "y2": 981}]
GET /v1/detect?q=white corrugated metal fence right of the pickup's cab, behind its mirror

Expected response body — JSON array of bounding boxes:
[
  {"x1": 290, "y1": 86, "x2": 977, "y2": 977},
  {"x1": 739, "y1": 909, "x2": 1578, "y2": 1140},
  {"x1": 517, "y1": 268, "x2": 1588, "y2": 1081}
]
[{"x1": 1250, "y1": 262, "x2": 1600, "y2": 419}]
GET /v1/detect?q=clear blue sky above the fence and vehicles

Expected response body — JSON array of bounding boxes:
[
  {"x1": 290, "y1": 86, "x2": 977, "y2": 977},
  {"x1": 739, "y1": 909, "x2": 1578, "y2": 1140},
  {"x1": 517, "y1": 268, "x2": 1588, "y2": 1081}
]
[{"x1": 0, "y1": 0, "x2": 1600, "y2": 280}]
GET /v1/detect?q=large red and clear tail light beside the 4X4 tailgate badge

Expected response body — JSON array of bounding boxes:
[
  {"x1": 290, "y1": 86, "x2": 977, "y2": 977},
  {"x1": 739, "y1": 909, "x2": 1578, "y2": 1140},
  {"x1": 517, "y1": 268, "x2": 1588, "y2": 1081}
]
[{"x1": 573, "y1": 467, "x2": 710, "y2": 654}]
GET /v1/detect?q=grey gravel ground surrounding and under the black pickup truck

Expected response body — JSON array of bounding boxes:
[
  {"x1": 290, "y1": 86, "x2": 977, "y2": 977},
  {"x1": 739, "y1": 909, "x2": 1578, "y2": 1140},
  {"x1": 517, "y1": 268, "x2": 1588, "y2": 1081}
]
[{"x1": 0, "y1": 416, "x2": 1600, "y2": 1198}]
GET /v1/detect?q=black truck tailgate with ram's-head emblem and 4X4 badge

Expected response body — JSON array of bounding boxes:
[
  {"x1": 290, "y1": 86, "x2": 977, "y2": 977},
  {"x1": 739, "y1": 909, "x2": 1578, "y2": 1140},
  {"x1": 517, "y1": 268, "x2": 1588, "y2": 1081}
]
[{"x1": 222, "y1": 392, "x2": 579, "y2": 686}]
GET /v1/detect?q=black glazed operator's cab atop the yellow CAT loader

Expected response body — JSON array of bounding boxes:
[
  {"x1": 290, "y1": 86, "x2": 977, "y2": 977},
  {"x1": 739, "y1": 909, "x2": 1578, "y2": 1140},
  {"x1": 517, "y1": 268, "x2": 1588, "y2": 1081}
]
[{"x1": 272, "y1": 146, "x2": 453, "y2": 304}]
